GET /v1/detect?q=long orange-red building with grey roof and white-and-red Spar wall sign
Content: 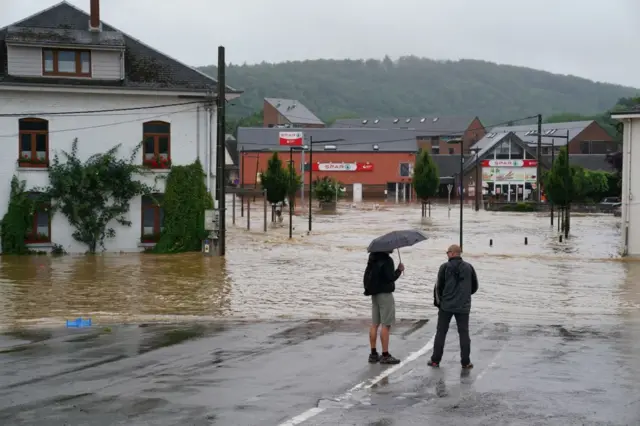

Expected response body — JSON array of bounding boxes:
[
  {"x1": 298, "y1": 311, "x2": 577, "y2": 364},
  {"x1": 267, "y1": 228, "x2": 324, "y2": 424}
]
[{"x1": 238, "y1": 127, "x2": 468, "y2": 200}]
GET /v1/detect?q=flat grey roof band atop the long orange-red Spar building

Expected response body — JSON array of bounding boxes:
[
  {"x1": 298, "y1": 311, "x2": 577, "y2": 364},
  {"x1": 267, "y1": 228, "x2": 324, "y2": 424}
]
[{"x1": 238, "y1": 127, "x2": 418, "y2": 152}]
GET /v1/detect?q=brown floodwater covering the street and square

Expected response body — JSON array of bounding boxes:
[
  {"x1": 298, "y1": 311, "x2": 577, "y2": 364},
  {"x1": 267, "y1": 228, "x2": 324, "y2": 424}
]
[{"x1": 0, "y1": 198, "x2": 640, "y2": 328}]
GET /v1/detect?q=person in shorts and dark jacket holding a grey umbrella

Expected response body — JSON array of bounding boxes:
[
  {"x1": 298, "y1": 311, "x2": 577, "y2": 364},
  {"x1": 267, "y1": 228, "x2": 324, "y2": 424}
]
[{"x1": 363, "y1": 231, "x2": 427, "y2": 364}]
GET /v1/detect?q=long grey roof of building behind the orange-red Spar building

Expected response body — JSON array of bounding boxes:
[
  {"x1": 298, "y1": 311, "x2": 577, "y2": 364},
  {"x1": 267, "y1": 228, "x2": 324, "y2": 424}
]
[{"x1": 331, "y1": 116, "x2": 477, "y2": 136}]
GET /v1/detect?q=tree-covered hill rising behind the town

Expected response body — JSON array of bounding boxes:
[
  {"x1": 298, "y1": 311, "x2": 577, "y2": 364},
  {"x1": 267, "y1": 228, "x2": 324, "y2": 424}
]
[{"x1": 201, "y1": 57, "x2": 640, "y2": 123}]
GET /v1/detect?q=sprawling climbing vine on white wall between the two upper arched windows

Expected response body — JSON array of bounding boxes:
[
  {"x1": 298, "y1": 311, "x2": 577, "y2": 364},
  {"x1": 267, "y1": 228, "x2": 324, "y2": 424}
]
[{"x1": 42, "y1": 139, "x2": 152, "y2": 253}]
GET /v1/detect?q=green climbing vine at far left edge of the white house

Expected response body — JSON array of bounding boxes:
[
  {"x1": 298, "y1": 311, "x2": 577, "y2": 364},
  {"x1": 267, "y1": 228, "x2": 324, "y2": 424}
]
[{"x1": 0, "y1": 176, "x2": 44, "y2": 254}]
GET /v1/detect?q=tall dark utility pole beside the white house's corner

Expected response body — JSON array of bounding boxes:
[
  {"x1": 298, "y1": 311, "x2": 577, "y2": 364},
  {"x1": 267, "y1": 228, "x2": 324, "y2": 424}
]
[{"x1": 216, "y1": 46, "x2": 227, "y2": 256}]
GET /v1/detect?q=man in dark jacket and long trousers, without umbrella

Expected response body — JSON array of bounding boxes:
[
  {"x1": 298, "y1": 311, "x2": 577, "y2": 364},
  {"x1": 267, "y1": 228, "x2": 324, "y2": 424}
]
[{"x1": 429, "y1": 245, "x2": 478, "y2": 369}]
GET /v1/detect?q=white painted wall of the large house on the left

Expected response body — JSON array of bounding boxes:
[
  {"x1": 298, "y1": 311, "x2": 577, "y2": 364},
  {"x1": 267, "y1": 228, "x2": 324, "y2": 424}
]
[{"x1": 0, "y1": 90, "x2": 216, "y2": 253}]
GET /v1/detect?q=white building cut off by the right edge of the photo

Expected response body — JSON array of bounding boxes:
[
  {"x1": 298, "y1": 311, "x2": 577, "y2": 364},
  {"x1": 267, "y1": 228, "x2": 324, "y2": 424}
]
[{"x1": 611, "y1": 107, "x2": 640, "y2": 257}]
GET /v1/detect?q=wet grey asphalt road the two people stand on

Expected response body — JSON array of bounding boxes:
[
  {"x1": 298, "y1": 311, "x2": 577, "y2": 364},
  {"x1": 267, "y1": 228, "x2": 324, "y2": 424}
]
[{"x1": 0, "y1": 317, "x2": 640, "y2": 426}]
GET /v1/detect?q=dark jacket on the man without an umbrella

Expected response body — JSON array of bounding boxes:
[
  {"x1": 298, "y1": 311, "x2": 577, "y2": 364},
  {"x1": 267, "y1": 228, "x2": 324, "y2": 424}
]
[{"x1": 433, "y1": 256, "x2": 478, "y2": 314}]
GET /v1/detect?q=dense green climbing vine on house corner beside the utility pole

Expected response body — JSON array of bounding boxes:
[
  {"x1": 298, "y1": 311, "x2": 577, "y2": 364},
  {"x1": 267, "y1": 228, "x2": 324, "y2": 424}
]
[{"x1": 153, "y1": 160, "x2": 213, "y2": 253}]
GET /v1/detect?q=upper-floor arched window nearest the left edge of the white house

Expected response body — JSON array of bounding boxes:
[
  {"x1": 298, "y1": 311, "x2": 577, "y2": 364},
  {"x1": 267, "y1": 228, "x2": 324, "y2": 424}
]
[{"x1": 18, "y1": 118, "x2": 49, "y2": 167}]
